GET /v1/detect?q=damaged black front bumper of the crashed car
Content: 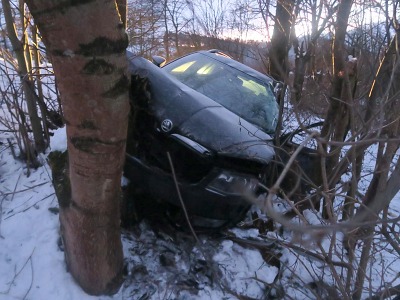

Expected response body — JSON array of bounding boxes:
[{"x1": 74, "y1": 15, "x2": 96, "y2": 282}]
[{"x1": 124, "y1": 154, "x2": 258, "y2": 221}]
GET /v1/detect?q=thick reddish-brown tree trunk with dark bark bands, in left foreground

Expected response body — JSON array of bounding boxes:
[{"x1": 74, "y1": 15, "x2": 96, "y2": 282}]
[{"x1": 26, "y1": 0, "x2": 129, "y2": 295}]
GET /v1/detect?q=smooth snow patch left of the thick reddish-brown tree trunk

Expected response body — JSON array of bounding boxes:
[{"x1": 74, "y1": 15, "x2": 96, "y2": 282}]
[{"x1": 0, "y1": 128, "x2": 99, "y2": 299}]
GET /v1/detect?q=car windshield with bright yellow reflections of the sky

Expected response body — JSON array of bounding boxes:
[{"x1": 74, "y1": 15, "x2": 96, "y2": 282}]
[{"x1": 163, "y1": 53, "x2": 279, "y2": 133}]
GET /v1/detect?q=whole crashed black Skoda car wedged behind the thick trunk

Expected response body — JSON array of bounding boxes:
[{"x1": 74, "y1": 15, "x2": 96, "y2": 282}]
[{"x1": 124, "y1": 50, "x2": 279, "y2": 223}]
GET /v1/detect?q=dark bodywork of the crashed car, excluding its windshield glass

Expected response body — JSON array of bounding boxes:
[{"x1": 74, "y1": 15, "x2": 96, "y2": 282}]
[{"x1": 124, "y1": 49, "x2": 282, "y2": 222}]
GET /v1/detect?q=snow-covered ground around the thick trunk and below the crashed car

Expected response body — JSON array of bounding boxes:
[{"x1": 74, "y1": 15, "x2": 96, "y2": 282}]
[{"x1": 0, "y1": 115, "x2": 400, "y2": 300}]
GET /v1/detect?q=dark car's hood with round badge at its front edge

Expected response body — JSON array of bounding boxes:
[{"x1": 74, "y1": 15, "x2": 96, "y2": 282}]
[{"x1": 128, "y1": 55, "x2": 275, "y2": 163}]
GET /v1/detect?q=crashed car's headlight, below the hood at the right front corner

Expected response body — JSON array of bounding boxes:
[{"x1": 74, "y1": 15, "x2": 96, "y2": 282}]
[{"x1": 207, "y1": 171, "x2": 258, "y2": 195}]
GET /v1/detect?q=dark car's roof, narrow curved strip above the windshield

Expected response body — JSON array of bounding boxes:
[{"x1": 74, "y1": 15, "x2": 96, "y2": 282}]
[{"x1": 166, "y1": 49, "x2": 278, "y2": 84}]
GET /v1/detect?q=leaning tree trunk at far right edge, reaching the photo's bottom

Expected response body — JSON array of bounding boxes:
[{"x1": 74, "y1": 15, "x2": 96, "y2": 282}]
[{"x1": 344, "y1": 30, "x2": 400, "y2": 299}]
